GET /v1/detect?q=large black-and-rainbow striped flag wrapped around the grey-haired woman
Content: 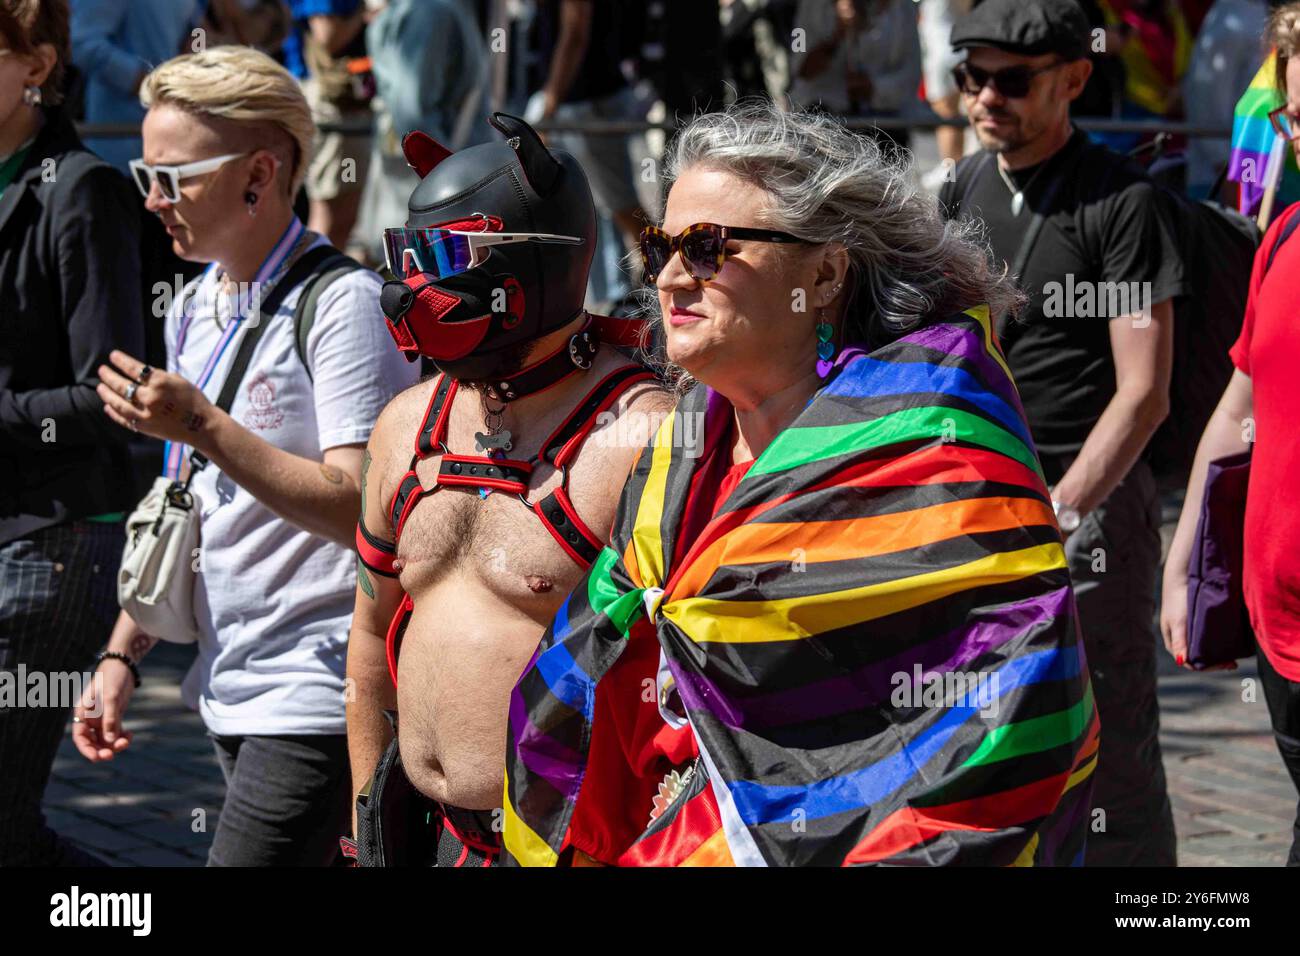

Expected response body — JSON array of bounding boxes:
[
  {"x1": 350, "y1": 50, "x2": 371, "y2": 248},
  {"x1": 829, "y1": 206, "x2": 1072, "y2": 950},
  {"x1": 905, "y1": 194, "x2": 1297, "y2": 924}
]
[{"x1": 504, "y1": 307, "x2": 1099, "y2": 866}]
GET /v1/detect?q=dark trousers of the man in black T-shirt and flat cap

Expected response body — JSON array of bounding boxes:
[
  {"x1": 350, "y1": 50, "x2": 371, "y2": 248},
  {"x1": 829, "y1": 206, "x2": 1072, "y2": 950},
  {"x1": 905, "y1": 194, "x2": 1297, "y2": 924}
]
[{"x1": 1044, "y1": 457, "x2": 1177, "y2": 866}]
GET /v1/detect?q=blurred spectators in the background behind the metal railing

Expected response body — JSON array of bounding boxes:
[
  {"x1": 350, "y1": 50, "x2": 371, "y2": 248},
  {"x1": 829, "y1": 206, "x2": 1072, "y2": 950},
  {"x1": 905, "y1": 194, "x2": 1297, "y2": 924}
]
[{"x1": 58, "y1": 0, "x2": 1277, "y2": 303}]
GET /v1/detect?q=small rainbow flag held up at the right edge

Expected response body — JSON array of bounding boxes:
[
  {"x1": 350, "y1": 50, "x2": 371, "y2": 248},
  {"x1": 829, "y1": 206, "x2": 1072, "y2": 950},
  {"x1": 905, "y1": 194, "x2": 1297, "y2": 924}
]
[{"x1": 1227, "y1": 51, "x2": 1300, "y2": 216}]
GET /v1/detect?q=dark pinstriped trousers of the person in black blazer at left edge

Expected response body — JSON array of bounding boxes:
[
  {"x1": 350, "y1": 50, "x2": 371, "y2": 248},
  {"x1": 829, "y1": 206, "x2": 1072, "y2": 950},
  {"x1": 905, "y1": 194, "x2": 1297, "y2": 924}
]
[{"x1": 0, "y1": 522, "x2": 122, "y2": 866}]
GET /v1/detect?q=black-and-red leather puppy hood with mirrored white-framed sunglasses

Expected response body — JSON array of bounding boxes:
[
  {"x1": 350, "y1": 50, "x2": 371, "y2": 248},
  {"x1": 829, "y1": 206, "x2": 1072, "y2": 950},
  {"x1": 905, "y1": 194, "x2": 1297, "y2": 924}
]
[{"x1": 382, "y1": 113, "x2": 595, "y2": 381}]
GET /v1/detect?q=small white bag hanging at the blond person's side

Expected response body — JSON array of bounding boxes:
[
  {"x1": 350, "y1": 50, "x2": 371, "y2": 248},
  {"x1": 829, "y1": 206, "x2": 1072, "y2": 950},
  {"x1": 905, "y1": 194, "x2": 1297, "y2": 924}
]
[{"x1": 117, "y1": 471, "x2": 200, "y2": 644}]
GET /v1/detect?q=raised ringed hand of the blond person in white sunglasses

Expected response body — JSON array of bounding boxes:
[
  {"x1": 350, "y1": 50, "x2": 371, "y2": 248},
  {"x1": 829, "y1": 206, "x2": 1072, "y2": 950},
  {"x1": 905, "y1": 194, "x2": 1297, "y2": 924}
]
[{"x1": 95, "y1": 351, "x2": 216, "y2": 450}]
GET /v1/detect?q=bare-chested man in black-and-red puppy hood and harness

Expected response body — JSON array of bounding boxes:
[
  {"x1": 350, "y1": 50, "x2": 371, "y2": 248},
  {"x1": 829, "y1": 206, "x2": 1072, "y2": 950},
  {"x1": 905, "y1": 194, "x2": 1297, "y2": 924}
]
[{"x1": 345, "y1": 113, "x2": 670, "y2": 866}]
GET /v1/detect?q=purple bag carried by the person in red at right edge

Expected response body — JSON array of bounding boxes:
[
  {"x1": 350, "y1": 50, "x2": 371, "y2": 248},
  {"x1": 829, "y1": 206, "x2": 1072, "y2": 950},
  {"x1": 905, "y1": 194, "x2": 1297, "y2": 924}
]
[{"x1": 1187, "y1": 451, "x2": 1255, "y2": 670}]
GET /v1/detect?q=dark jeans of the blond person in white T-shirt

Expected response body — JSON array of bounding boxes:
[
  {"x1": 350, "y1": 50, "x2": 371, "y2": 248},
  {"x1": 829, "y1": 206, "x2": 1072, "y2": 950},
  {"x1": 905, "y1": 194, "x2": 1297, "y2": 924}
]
[{"x1": 208, "y1": 734, "x2": 352, "y2": 866}]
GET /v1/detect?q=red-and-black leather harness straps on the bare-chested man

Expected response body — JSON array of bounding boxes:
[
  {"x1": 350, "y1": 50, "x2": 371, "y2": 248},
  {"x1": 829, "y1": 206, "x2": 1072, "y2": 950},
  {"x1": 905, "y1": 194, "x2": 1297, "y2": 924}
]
[{"x1": 379, "y1": 365, "x2": 654, "y2": 687}]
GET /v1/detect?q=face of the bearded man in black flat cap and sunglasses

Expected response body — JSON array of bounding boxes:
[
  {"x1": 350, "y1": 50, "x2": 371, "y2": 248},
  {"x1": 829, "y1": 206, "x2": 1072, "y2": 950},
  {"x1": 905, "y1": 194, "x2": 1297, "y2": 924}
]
[{"x1": 962, "y1": 47, "x2": 1091, "y2": 152}]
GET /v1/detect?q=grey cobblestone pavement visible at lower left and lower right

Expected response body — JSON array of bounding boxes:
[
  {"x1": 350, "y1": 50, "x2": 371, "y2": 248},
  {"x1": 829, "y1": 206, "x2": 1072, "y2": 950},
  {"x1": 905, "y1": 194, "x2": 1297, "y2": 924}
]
[{"x1": 35, "y1": 502, "x2": 1296, "y2": 866}]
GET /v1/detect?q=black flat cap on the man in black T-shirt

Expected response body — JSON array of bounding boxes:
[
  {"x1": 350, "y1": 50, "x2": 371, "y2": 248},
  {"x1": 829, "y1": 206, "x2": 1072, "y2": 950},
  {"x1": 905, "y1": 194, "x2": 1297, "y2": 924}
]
[{"x1": 950, "y1": 0, "x2": 1092, "y2": 60}]
